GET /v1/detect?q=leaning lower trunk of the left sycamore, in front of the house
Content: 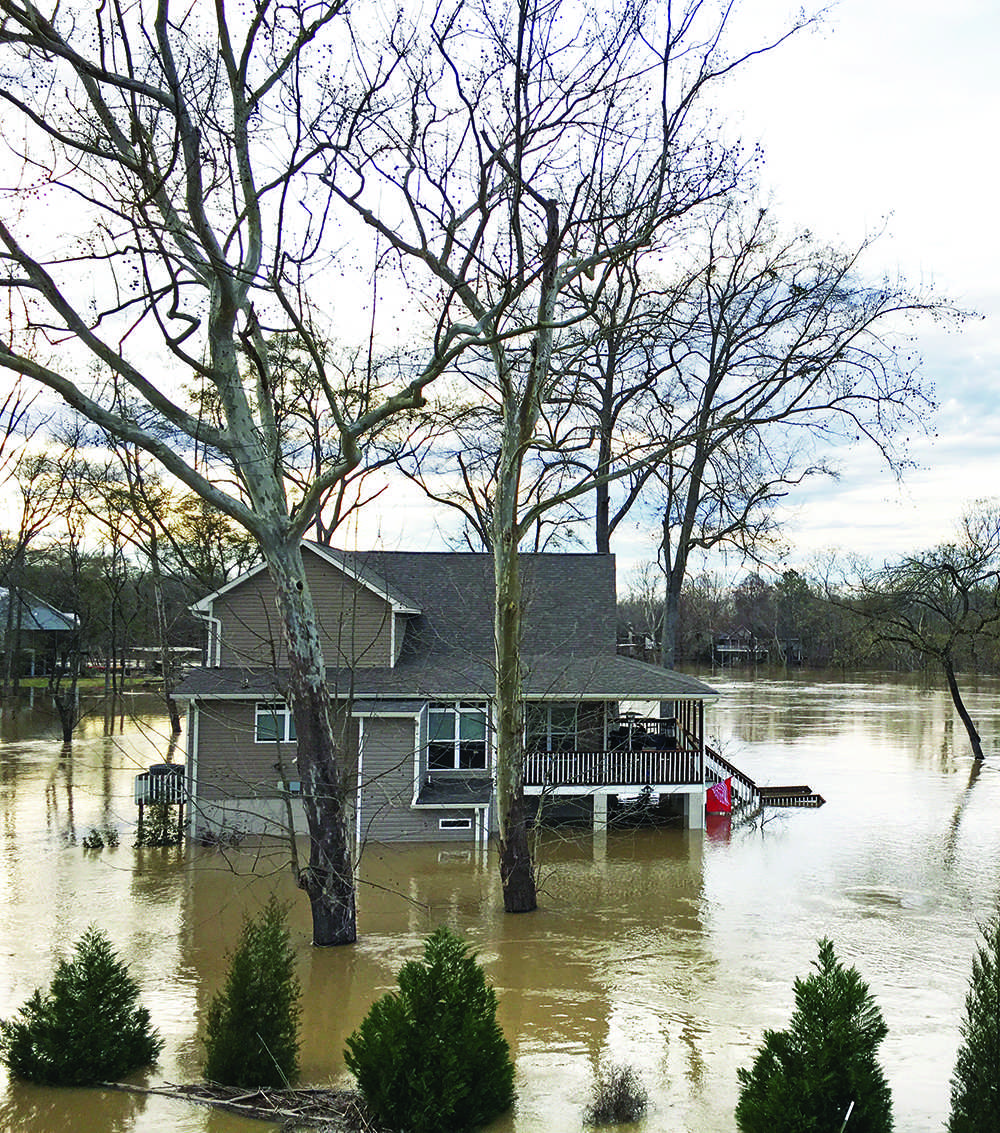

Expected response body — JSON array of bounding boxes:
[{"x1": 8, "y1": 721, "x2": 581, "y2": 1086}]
[{"x1": 265, "y1": 546, "x2": 358, "y2": 945}]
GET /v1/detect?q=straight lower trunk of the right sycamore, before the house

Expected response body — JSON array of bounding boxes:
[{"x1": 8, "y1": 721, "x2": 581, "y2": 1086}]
[{"x1": 494, "y1": 537, "x2": 538, "y2": 913}]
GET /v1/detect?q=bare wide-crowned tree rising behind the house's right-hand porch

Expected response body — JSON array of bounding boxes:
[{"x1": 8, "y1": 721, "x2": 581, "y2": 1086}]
[{"x1": 575, "y1": 202, "x2": 959, "y2": 667}]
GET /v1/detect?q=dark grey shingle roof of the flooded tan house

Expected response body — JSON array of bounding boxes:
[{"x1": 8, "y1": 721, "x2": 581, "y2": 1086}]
[{"x1": 176, "y1": 543, "x2": 716, "y2": 702}]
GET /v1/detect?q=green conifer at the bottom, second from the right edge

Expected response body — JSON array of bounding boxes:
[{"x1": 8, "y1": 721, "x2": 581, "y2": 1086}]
[{"x1": 736, "y1": 940, "x2": 892, "y2": 1133}]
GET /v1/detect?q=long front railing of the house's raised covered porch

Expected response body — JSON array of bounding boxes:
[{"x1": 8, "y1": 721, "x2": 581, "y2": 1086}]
[{"x1": 524, "y1": 749, "x2": 702, "y2": 786}]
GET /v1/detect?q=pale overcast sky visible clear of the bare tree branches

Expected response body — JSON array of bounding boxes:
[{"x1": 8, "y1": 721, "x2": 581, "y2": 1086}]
[{"x1": 356, "y1": 0, "x2": 1000, "y2": 580}]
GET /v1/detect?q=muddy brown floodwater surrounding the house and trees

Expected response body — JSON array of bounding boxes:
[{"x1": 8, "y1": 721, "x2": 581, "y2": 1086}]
[{"x1": 0, "y1": 673, "x2": 1000, "y2": 1133}]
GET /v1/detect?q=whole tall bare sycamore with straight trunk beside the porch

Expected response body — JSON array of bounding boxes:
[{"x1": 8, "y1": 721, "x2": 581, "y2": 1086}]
[{"x1": 331, "y1": 0, "x2": 810, "y2": 912}]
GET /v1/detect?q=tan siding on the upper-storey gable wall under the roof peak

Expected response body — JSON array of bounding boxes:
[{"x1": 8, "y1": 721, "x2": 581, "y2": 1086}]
[{"x1": 212, "y1": 548, "x2": 394, "y2": 668}]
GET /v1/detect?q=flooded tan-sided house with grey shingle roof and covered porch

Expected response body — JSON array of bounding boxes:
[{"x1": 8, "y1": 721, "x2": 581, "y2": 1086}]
[{"x1": 177, "y1": 544, "x2": 715, "y2": 842}]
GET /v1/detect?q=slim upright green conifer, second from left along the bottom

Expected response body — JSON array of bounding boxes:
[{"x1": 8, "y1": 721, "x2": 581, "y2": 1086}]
[{"x1": 205, "y1": 896, "x2": 301, "y2": 1089}]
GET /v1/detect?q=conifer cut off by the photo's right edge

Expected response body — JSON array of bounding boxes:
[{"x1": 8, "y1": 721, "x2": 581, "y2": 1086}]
[{"x1": 948, "y1": 915, "x2": 1000, "y2": 1133}]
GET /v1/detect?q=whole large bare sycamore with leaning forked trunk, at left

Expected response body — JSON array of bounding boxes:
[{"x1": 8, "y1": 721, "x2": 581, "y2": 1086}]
[{"x1": 0, "y1": 0, "x2": 475, "y2": 944}]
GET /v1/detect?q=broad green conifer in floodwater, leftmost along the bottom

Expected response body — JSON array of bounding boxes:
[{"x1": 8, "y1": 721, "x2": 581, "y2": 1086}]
[{"x1": 0, "y1": 927, "x2": 163, "y2": 1085}]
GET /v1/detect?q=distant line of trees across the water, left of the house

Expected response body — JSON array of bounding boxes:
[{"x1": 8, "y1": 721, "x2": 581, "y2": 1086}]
[{"x1": 0, "y1": 433, "x2": 256, "y2": 690}]
